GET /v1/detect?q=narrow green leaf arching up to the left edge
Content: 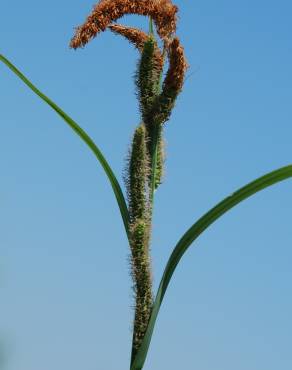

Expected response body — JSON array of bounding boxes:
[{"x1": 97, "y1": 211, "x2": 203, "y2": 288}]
[{"x1": 0, "y1": 54, "x2": 129, "y2": 237}]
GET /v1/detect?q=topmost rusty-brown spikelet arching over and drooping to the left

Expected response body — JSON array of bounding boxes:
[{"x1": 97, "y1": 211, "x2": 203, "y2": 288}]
[{"x1": 70, "y1": 0, "x2": 178, "y2": 49}]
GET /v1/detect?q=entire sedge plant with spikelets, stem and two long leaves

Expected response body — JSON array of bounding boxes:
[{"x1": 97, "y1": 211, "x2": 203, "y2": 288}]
[{"x1": 0, "y1": 0, "x2": 292, "y2": 370}]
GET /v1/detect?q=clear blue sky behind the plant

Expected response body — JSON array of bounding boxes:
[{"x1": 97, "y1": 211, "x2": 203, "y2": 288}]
[{"x1": 0, "y1": 0, "x2": 292, "y2": 370}]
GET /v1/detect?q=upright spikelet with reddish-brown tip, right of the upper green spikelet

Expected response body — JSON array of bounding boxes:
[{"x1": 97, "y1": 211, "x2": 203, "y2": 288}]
[{"x1": 152, "y1": 37, "x2": 188, "y2": 124}]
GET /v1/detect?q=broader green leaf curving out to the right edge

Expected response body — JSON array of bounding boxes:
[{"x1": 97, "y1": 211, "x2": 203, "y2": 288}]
[{"x1": 131, "y1": 165, "x2": 292, "y2": 370}]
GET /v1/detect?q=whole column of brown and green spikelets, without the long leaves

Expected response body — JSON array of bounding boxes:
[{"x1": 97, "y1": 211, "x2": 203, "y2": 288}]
[{"x1": 70, "y1": 0, "x2": 187, "y2": 358}]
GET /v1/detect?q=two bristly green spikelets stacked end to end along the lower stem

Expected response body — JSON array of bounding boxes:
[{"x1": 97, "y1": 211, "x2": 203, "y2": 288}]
[{"x1": 126, "y1": 124, "x2": 153, "y2": 351}]
